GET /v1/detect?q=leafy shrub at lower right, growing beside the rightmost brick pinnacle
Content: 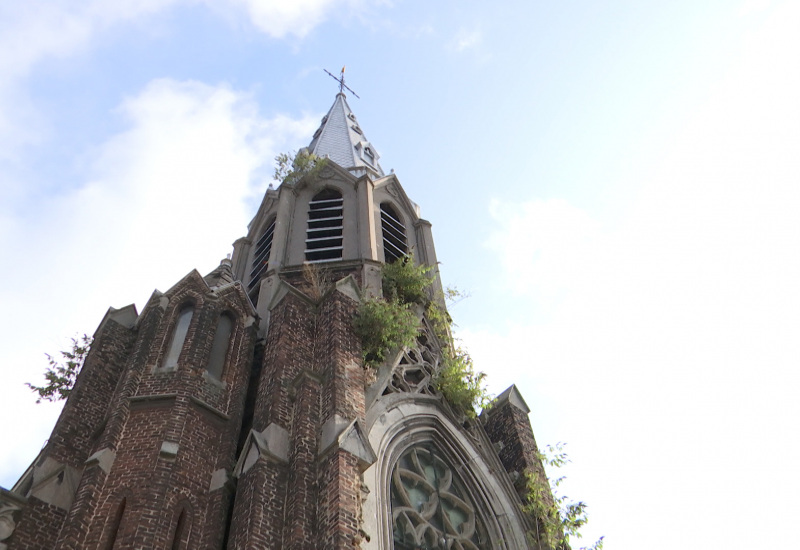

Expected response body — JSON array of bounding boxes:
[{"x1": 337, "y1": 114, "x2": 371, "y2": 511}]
[{"x1": 523, "y1": 443, "x2": 603, "y2": 550}]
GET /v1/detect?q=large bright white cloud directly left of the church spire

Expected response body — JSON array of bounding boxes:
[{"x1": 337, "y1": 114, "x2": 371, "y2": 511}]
[{"x1": 0, "y1": 79, "x2": 318, "y2": 486}]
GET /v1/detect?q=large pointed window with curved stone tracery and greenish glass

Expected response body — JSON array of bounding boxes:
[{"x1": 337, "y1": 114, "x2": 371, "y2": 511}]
[{"x1": 391, "y1": 443, "x2": 490, "y2": 550}]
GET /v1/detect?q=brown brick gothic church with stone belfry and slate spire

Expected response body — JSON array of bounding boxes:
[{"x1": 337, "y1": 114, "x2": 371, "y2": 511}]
[{"x1": 0, "y1": 89, "x2": 545, "y2": 550}]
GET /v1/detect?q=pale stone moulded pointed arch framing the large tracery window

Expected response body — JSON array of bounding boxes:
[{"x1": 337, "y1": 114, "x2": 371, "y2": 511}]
[{"x1": 364, "y1": 402, "x2": 527, "y2": 550}]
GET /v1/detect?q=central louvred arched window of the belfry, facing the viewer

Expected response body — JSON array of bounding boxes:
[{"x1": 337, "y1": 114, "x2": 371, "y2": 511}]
[{"x1": 306, "y1": 189, "x2": 344, "y2": 262}]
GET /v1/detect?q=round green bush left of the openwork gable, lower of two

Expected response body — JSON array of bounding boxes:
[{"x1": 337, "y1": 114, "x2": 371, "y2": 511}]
[{"x1": 353, "y1": 299, "x2": 419, "y2": 367}]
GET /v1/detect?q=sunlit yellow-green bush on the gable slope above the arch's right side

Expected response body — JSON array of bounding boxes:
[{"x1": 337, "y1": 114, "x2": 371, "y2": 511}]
[{"x1": 434, "y1": 346, "x2": 491, "y2": 418}]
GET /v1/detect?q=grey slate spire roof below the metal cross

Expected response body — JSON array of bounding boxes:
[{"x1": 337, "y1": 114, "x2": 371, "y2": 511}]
[{"x1": 308, "y1": 93, "x2": 384, "y2": 177}]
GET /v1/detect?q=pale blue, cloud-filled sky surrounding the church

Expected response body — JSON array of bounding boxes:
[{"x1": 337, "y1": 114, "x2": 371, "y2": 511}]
[{"x1": 0, "y1": 0, "x2": 800, "y2": 549}]
